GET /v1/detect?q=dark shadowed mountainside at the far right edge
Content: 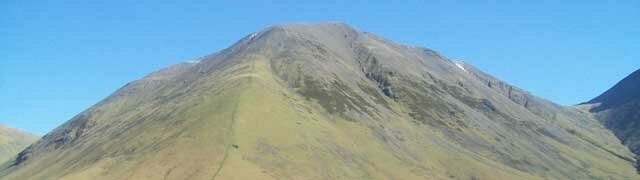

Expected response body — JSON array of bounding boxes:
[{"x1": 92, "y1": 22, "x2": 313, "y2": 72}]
[{"x1": 583, "y1": 70, "x2": 640, "y2": 171}]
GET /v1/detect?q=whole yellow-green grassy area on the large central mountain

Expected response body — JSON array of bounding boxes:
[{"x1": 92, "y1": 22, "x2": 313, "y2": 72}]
[{"x1": 0, "y1": 52, "x2": 533, "y2": 179}]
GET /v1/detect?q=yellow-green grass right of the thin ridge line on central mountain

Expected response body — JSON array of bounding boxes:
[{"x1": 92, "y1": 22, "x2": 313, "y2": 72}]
[{"x1": 212, "y1": 54, "x2": 532, "y2": 179}]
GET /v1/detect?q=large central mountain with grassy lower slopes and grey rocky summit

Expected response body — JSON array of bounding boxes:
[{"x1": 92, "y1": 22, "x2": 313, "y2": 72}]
[{"x1": 0, "y1": 23, "x2": 640, "y2": 179}]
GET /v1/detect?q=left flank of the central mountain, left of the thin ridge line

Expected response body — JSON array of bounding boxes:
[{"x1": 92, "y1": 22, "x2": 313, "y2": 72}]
[{"x1": 3, "y1": 54, "x2": 247, "y2": 179}]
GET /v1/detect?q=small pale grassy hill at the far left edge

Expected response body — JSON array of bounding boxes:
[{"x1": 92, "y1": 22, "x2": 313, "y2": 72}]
[{"x1": 0, "y1": 124, "x2": 39, "y2": 163}]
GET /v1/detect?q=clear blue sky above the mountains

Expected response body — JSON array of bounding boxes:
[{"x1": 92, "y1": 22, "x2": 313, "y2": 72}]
[{"x1": 0, "y1": 0, "x2": 640, "y2": 134}]
